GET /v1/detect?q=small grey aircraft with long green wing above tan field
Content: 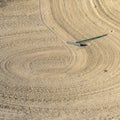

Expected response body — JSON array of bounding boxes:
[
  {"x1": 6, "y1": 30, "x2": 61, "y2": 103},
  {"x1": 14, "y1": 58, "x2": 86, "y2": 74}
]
[{"x1": 67, "y1": 34, "x2": 108, "y2": 46}]
